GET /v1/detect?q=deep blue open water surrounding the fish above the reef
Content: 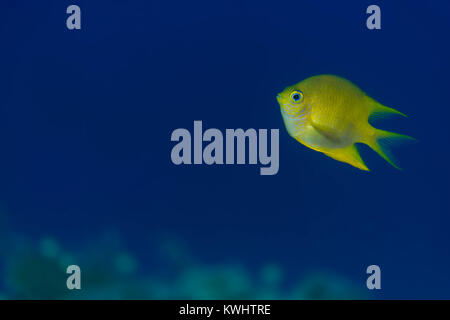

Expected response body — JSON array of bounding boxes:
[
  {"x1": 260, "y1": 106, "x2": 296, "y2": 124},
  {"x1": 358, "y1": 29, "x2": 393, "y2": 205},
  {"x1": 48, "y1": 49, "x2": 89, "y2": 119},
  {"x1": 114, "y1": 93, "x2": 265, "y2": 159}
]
[{"x1": 0, "y1": 0, "x2": 450, "y2": 299}]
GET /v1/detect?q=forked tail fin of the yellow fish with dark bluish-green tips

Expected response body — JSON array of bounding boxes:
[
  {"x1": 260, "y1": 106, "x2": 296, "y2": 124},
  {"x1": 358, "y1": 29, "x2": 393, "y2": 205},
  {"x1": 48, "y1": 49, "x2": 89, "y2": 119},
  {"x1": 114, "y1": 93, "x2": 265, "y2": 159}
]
[{"x1": 366, "y1": 128, "x2": 415, "y2": 170}]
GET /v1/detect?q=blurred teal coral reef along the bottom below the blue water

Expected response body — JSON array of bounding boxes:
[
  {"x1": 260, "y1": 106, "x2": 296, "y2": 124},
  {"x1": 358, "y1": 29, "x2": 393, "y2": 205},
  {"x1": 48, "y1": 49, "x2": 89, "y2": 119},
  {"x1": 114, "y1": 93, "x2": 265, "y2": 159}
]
[{"x1": 0, "y1": 214, "x2": 366, "y2": 299}]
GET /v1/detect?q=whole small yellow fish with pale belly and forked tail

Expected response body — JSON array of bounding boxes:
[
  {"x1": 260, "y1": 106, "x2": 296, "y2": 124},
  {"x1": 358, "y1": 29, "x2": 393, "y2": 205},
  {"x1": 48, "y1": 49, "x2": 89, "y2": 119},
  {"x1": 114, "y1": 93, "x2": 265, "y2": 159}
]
[{"x1": 277, "y1": 75, "x2": 412, "y2": 171}]
